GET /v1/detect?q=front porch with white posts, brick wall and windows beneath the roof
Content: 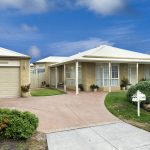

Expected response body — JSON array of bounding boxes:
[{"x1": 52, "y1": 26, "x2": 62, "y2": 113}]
[{"x1": 50, "y1": 61, "x2": 150, "y2": 94}]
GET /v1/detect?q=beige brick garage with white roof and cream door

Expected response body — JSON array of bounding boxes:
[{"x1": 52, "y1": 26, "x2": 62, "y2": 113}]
[{"x1": 0, "y1": 48, "x2": 30, "y2": 98}]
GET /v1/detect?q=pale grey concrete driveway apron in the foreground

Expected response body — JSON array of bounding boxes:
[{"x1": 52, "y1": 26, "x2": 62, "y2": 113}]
[{"x1": 47, "y1": 122, "x2": 150, "y2": 150}]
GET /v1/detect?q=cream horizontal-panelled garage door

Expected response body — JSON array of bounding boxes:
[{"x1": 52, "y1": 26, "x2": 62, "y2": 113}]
[{"x1": 0, "y1": 67, "x2": 20, "y2": 97}]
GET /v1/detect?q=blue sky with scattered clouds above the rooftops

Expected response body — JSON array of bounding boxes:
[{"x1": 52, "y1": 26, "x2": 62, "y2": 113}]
[{"x1": 0, "y1": 0, "x2": 150, "y2": 61}]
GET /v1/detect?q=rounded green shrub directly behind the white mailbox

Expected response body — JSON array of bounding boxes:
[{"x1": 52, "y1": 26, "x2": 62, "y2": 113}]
[{"x1": 127, "y1": 81, "x2": 150, "y2": 104}]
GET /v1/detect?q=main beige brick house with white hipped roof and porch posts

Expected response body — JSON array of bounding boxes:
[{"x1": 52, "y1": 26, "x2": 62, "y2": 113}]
[{"x1": 50, "y1": 45, "x2": 150, "y2": 94}]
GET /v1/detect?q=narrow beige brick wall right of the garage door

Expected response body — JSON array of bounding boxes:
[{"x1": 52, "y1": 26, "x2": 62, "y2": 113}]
[{"x1": 20, "y1": 59, "x2": 30, "y2": 85}]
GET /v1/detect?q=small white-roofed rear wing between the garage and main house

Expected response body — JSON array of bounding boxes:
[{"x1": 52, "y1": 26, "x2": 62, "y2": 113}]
[{"x1": 30, "y1": 56, "x2": 67, "y2": 88}]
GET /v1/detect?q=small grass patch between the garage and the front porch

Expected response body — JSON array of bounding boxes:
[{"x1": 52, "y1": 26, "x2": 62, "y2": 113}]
[{"x1": 31, "y1": 88, "x2": 65, "y2": 96}]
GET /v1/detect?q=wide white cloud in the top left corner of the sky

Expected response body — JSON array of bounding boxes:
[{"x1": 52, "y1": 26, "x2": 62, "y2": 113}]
[{"x1": 0, "y1": 0, "x2": 48, "y2": 13}]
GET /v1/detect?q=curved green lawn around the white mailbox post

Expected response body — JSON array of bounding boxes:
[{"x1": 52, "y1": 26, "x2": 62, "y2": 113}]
[{"x1": 105, "y1": 92, "x2": 150, "y2": 131}]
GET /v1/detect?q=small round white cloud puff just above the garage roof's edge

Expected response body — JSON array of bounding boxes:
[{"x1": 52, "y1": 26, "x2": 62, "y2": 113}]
[{"x1": 29, "y1": 46, "x2": 41, "y2": 58}]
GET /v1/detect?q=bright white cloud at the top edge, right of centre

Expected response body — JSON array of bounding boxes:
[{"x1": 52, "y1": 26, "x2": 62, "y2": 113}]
[{"x1": 77, "y1": 0, "x2": 125, "y2": 15}]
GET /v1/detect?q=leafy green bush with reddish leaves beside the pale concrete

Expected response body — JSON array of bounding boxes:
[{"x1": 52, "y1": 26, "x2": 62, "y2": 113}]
[{"x1": 0, "y1": 109, "x2": 39, "y2": 139}]
